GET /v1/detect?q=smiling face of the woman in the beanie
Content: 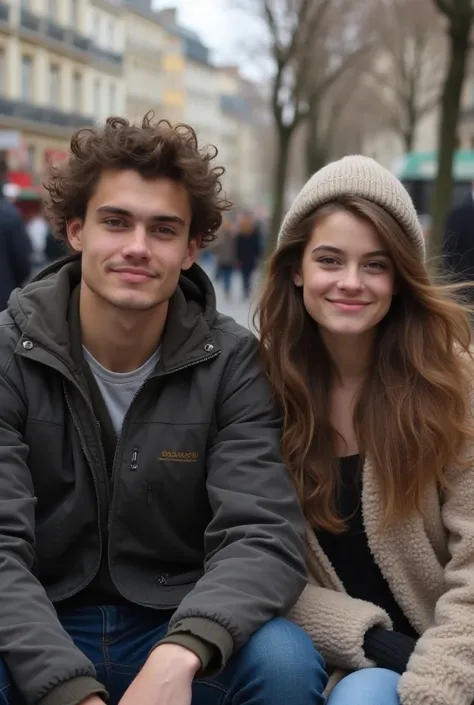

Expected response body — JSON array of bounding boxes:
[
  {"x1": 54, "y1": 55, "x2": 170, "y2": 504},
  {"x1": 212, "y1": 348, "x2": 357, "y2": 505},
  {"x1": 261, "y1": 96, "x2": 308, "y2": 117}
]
[{"x1": 294, "y1": 210, "x2": 395, "y2": 336}]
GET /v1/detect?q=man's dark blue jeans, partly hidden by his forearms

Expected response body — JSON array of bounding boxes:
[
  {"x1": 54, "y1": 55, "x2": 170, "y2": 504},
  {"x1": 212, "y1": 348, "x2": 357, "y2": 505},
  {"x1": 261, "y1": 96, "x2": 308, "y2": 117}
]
[{"x1": 0, "y1": 605, "x2": 327, "y2": 705}]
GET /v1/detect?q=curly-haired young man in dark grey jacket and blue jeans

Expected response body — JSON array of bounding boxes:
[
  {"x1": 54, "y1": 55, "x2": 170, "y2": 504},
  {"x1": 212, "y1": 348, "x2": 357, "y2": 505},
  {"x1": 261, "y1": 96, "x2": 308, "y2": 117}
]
[{"x1": 0, "y1": 118, "x2": 325, "y2": 705}]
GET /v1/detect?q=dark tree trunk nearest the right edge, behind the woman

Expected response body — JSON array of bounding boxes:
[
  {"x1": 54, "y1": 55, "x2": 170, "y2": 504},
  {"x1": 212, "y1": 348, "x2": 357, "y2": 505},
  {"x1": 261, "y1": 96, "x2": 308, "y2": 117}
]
[{"x1": 429, "y1": 19, "x2": 472, "y2": 255}]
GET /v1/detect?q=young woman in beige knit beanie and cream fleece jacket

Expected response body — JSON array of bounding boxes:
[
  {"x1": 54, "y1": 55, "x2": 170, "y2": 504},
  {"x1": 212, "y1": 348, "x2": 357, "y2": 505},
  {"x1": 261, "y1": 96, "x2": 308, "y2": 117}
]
[{"x1": 259, "y1": 156, "x2": 474, "y2": 705}]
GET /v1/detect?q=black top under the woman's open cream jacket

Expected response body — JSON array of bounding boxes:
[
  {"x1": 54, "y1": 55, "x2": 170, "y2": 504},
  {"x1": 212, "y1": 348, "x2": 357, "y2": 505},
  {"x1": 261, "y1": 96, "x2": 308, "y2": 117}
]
[{"x1": 315, "y1": 455, "x2": 417, "y2": 638}]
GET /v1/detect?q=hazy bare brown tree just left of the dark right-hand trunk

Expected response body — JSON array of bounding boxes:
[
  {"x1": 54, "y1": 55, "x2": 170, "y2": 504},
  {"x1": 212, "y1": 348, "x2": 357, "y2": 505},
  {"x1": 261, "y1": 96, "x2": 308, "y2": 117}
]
[{"x1": 367, "y1": 0, "x2": 445, "y2": 152}]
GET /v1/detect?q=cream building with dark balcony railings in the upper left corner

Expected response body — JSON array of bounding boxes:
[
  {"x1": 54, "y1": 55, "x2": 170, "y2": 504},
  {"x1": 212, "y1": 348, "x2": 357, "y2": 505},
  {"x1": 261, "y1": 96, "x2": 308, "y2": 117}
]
[{"x1": 0, "y1": 0, "x2": 125, "y2": 179}]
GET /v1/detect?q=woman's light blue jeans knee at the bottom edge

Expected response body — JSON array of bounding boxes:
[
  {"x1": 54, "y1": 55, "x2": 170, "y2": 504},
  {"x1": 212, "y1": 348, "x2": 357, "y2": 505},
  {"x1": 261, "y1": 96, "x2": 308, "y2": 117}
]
[{"x1": 327, "y1": 668, "x2": 400, "y2": 705}]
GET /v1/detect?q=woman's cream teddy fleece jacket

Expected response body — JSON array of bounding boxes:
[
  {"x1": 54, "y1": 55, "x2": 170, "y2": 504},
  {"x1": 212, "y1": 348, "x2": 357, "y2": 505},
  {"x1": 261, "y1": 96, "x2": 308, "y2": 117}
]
[{"x1": 290, "y1": 458, "x2": 474, "y2": 705}]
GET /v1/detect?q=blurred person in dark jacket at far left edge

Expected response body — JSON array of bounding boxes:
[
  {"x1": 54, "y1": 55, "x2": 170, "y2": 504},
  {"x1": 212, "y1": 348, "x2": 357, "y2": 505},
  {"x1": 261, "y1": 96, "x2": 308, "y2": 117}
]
[{"x1": 0, "y1": 164, "x2": 32, "y2": 311}]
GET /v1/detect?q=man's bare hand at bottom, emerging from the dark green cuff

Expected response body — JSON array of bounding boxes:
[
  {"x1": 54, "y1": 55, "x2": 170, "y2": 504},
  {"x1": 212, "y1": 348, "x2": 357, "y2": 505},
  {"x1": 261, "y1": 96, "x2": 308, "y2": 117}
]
[{"x1": 120, "y1": 644, "x2": 201, "y2": 705}]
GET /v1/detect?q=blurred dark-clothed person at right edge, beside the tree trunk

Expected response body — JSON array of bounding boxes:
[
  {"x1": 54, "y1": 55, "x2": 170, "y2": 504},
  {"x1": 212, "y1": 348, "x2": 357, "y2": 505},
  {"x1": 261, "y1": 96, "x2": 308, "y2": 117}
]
[{"x1": 443, "y1": 183, "x2": 474, "y2": 288}]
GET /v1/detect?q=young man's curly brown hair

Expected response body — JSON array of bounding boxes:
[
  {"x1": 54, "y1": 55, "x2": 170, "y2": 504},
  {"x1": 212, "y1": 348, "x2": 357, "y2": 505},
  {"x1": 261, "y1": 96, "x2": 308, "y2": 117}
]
[{"x1": 44, "y1": 112, "x2": 232, "y2": 247}]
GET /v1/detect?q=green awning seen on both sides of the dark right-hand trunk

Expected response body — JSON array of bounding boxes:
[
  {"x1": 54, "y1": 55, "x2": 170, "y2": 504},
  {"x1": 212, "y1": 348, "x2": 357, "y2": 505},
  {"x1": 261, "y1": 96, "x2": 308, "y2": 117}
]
[{"x1": 392, "y1": 149, "x2": 474, "y2": 181}]
